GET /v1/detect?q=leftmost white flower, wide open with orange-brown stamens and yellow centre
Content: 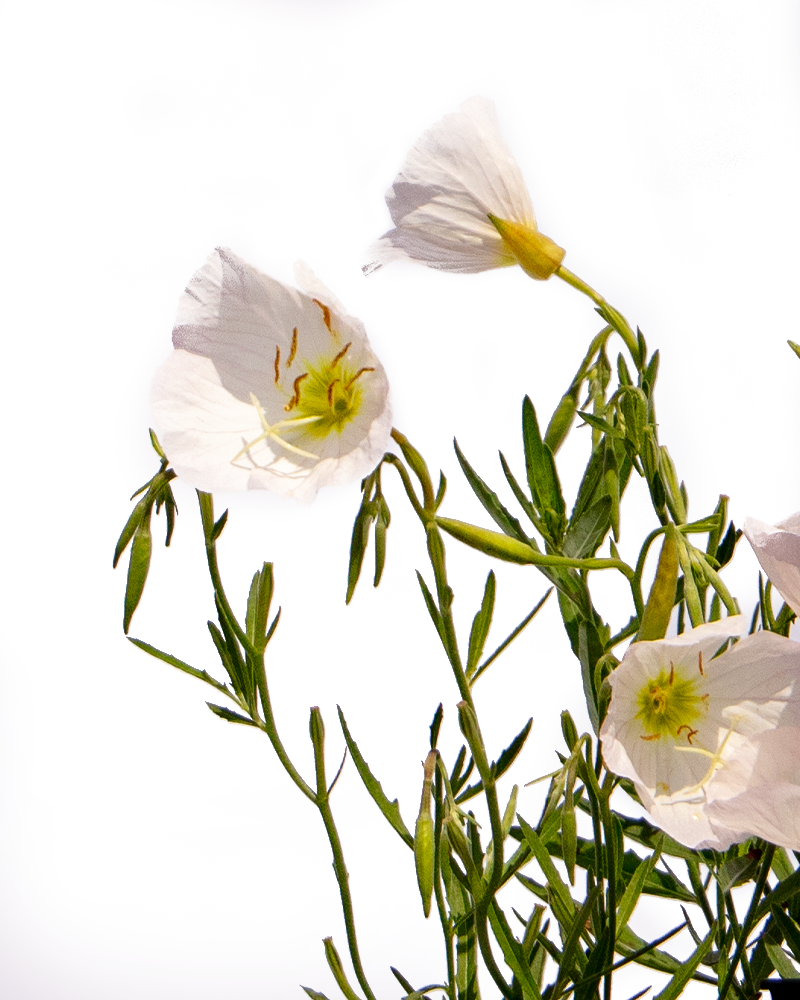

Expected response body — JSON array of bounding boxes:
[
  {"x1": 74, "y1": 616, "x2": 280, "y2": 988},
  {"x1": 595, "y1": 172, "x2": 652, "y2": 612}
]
[{"x1": 151, "y1": 249, "x2": 391, "y2": 501}]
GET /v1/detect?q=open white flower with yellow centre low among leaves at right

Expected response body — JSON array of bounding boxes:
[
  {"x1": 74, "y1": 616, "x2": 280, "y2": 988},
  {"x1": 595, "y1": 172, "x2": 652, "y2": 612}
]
[{"x1": 600, "y1": 616, "x2": 800, "y2": 850}]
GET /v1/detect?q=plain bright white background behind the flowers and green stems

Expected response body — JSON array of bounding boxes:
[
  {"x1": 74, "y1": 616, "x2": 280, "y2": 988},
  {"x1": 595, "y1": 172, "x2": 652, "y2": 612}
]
[{"x1": 0, "y1": 0, "x2": 800, "y2": 1000}]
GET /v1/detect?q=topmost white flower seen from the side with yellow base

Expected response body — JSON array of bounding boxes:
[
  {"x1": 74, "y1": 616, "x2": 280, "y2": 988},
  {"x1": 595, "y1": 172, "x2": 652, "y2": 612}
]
[{"x1": 362, "y1": 97, "x2": 564, "y2": 279}]
